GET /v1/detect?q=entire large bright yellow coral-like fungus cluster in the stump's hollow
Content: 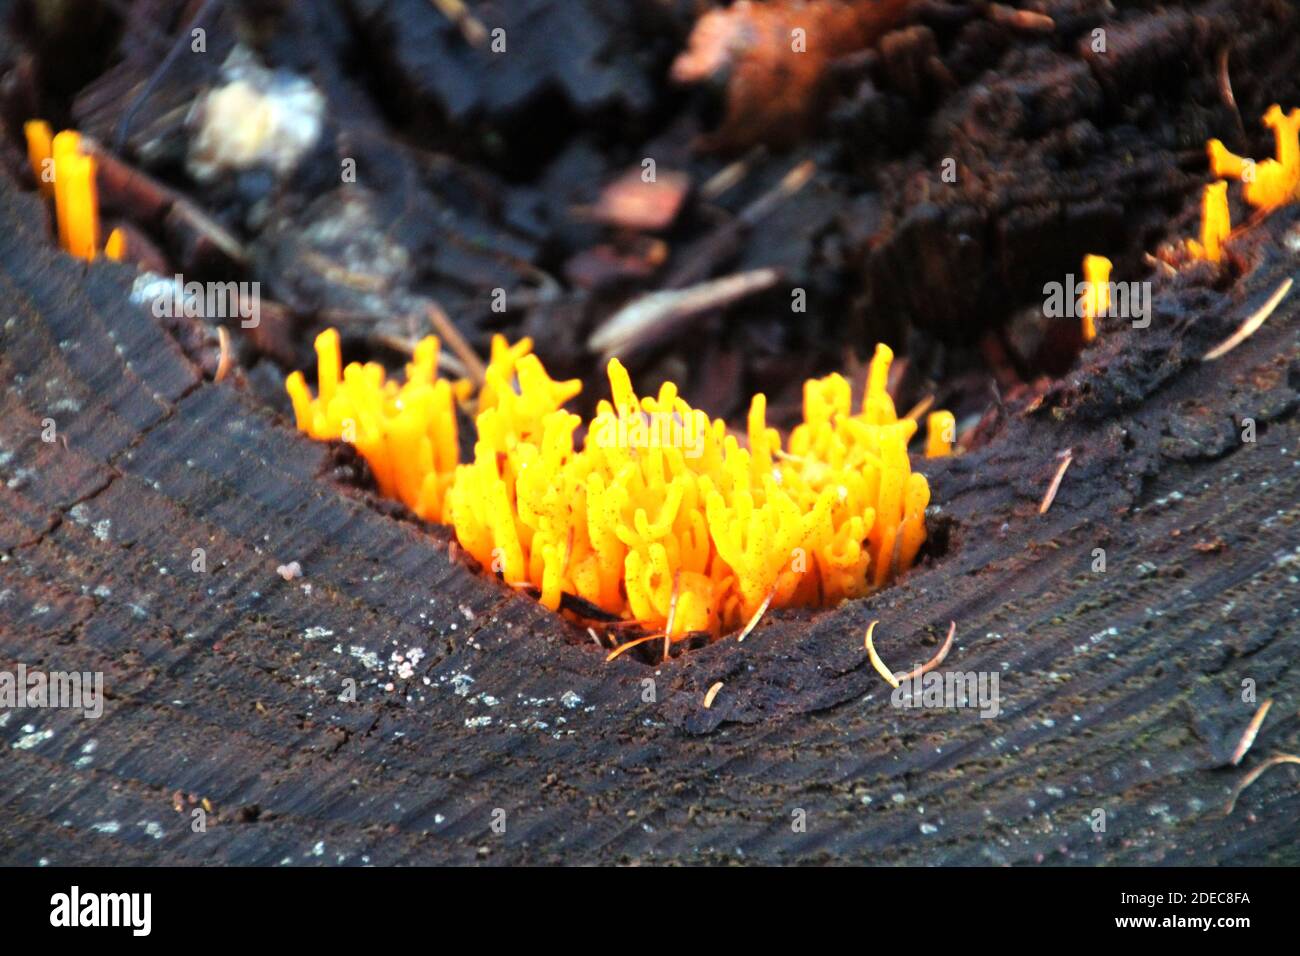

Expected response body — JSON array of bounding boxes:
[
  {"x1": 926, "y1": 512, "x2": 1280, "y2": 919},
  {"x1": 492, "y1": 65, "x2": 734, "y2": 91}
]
[{"x1": 287, "y1": 330, "x2": 946, "y2": 640}]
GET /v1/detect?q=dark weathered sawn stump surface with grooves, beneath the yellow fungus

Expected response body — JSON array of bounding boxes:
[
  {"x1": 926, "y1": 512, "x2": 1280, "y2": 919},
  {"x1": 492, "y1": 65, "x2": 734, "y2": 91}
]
[{"x1": 0, "y1": 162, "x2": 1300, "y2": 864}]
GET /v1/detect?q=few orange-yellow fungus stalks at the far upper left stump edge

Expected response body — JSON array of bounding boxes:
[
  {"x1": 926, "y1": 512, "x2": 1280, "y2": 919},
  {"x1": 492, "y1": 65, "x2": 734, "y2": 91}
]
[{"x1": 23, "y1": 120, "x2": 114, "y2": 261}]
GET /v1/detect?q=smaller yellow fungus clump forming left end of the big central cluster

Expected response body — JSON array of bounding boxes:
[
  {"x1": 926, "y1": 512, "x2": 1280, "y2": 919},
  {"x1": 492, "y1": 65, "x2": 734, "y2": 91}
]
[{"x1": 285, "y1": 329, "x2": 458, "y2": 522}]
